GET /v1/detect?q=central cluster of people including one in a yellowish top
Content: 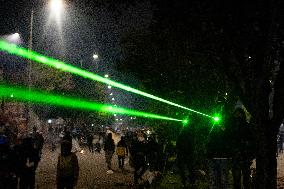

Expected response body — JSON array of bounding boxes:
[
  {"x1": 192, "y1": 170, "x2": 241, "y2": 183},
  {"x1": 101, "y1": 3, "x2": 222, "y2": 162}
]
[{"x1": 104, "y1": 132, "x2": 161, "y2": 185}]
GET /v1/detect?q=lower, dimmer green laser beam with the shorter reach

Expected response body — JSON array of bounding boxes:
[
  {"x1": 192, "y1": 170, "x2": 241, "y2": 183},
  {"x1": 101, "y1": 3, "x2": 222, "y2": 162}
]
[{"x1": 0, "y1": 85, "x2": 182, "y2": 122}]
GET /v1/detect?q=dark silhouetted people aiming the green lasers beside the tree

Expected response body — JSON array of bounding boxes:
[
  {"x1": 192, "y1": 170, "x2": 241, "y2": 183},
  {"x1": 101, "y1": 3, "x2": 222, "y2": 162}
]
[{"x1": 177, "y1": 108, "x2": 256, "y2": 189}]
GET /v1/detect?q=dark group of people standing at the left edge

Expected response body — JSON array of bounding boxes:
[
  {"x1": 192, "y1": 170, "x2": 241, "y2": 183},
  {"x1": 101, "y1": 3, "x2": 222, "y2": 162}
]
[{"x1": 0, "y1": 117, "x2": 44, "y2": 189}]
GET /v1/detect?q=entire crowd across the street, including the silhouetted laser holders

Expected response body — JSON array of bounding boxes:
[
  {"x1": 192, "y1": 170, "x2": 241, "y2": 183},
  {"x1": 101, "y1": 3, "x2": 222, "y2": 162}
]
[{"x1": 0, "y1": 108, "x2": 266, "y2": 189}]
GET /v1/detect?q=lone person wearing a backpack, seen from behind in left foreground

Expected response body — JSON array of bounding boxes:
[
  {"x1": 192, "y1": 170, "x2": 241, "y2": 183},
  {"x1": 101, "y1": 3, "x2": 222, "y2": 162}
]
[{"x1": 56, "y1": 140, "x2": 79, "y2": 189}]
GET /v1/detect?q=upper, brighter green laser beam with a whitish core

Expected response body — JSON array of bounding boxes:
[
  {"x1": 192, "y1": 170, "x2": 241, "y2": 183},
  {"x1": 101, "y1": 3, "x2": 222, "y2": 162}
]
[{"x1": 0, "y1": 40, "x2": 214, "y2": 119}]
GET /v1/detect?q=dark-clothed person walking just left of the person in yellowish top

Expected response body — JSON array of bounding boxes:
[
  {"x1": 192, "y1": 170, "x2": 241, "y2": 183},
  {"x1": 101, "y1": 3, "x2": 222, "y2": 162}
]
[{"x1": 104, "y1": 133, "x2": 115, "y2": 173}]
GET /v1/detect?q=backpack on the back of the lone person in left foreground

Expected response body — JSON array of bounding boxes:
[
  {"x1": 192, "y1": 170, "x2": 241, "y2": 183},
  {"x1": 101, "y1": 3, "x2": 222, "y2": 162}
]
[{"x1": 58, "y1": 154, "x2": 75, "y2": 177}]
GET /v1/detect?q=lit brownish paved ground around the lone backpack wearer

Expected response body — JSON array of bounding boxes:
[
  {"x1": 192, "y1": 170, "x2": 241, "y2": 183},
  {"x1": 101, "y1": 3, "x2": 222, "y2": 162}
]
[{"x1": 36, "y1": 146, "x2": 133, "y2": 189}]
